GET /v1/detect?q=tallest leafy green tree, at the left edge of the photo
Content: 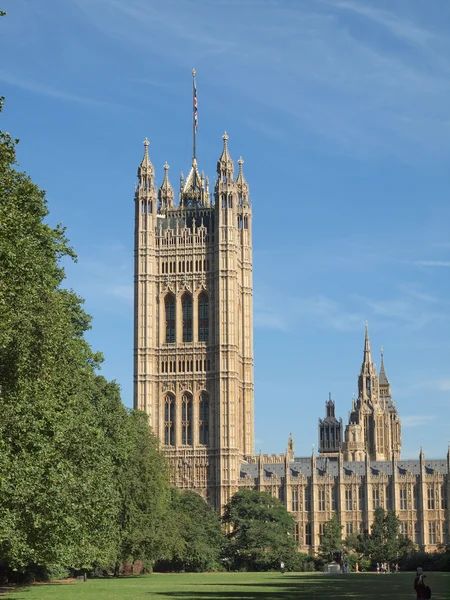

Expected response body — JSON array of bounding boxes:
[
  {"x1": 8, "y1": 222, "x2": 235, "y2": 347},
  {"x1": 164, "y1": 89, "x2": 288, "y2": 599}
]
[{"x1": 0, "y1": 101, "x2": 120, "y2": 571}]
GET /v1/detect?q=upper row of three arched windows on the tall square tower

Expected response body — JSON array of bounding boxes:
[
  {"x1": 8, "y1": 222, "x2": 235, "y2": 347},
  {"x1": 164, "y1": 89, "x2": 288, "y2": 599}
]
[{"x1": 164, "y1": 292, "x2": 209, "y2": 344}]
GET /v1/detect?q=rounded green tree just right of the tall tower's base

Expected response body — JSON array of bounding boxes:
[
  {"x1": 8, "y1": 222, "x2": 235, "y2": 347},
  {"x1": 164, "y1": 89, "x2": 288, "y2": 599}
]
[{"x1": 223, "y1": 490, "x2": 297, "y2": 571}]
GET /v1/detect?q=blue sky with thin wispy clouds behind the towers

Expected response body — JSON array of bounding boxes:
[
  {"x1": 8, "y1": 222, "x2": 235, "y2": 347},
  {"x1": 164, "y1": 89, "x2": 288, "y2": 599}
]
[{"x1": 0, "y1": 0, "x2": 450, "y2": 458}]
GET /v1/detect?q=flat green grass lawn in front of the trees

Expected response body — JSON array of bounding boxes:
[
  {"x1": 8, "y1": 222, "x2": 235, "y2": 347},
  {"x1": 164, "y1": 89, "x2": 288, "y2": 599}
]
[{"x1": 5, "y1": 573, "x2": 450, "y2": 600}]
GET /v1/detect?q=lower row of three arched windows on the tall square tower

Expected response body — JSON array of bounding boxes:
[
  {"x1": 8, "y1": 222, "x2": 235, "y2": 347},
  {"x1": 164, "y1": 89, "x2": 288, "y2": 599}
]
[{"x1": 164, "y1": 392, "x2": 209, "y2": 446}]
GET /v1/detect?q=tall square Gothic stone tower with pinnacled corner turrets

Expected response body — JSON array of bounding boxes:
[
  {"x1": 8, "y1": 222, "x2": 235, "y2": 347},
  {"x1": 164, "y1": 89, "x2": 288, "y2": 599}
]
[{"x1": 134, "y1": 134, "x2": 254, "y2": 509}]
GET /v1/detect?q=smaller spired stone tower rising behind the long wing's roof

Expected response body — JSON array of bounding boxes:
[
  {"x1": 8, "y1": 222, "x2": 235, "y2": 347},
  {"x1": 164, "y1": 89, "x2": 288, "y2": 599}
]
[{"x1": 343, "y1": 325, "x2": 401, "y2": 461}]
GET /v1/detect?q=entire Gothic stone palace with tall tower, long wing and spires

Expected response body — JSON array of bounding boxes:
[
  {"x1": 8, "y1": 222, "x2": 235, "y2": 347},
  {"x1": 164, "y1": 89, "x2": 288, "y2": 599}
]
[{"x1": 134, "y1": 103, "x2": 450, "y2": 554}]
